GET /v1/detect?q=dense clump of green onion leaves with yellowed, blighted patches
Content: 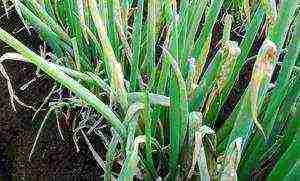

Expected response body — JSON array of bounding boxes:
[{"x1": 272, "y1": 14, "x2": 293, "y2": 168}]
[{"x1": 0, "y1": 0, "x2": 300, "y2": 180}]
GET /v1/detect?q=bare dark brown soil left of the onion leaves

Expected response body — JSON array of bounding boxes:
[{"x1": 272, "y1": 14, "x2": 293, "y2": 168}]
[{"x1": 0, "y1": 9, "x2": 101, "y2": 180}]
